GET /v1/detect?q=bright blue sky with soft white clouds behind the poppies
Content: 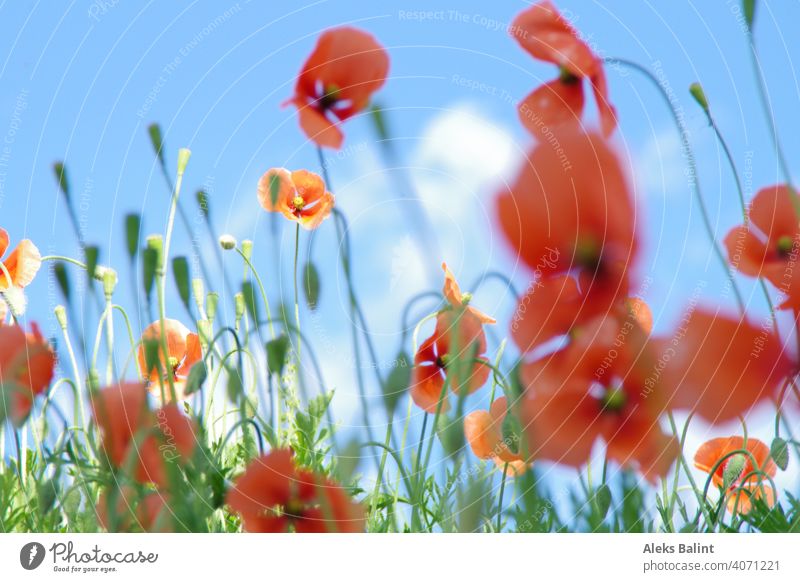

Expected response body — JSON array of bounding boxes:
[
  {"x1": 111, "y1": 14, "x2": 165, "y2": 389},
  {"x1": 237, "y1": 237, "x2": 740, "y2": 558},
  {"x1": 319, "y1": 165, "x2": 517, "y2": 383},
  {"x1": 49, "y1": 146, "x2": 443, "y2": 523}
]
[{"x1": 0, "y1": 0, "x2": 800, "y2": 520}]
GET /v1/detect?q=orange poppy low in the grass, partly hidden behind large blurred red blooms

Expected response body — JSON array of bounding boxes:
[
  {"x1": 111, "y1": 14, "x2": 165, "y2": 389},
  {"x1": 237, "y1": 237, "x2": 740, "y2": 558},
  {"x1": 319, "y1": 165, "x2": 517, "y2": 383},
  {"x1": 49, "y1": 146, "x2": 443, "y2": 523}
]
[{"x1": 464, "y1": 396, "x2": 528, "y2": 476}]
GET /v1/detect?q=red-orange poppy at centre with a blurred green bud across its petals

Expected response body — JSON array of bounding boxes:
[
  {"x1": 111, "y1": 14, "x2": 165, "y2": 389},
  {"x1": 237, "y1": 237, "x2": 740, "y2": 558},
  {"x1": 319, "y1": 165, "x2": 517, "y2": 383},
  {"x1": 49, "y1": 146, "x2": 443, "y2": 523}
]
[{"x1": 410, "y1": 308, "x2": 491, "y2": 413}]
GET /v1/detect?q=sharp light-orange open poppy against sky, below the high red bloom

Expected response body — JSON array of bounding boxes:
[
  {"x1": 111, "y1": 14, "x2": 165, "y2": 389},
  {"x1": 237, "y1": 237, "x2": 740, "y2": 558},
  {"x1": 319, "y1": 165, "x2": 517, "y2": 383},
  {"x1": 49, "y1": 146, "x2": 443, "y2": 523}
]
[{"x1": 258, "y1": 168, "x2": 334, "y2": 230}]
